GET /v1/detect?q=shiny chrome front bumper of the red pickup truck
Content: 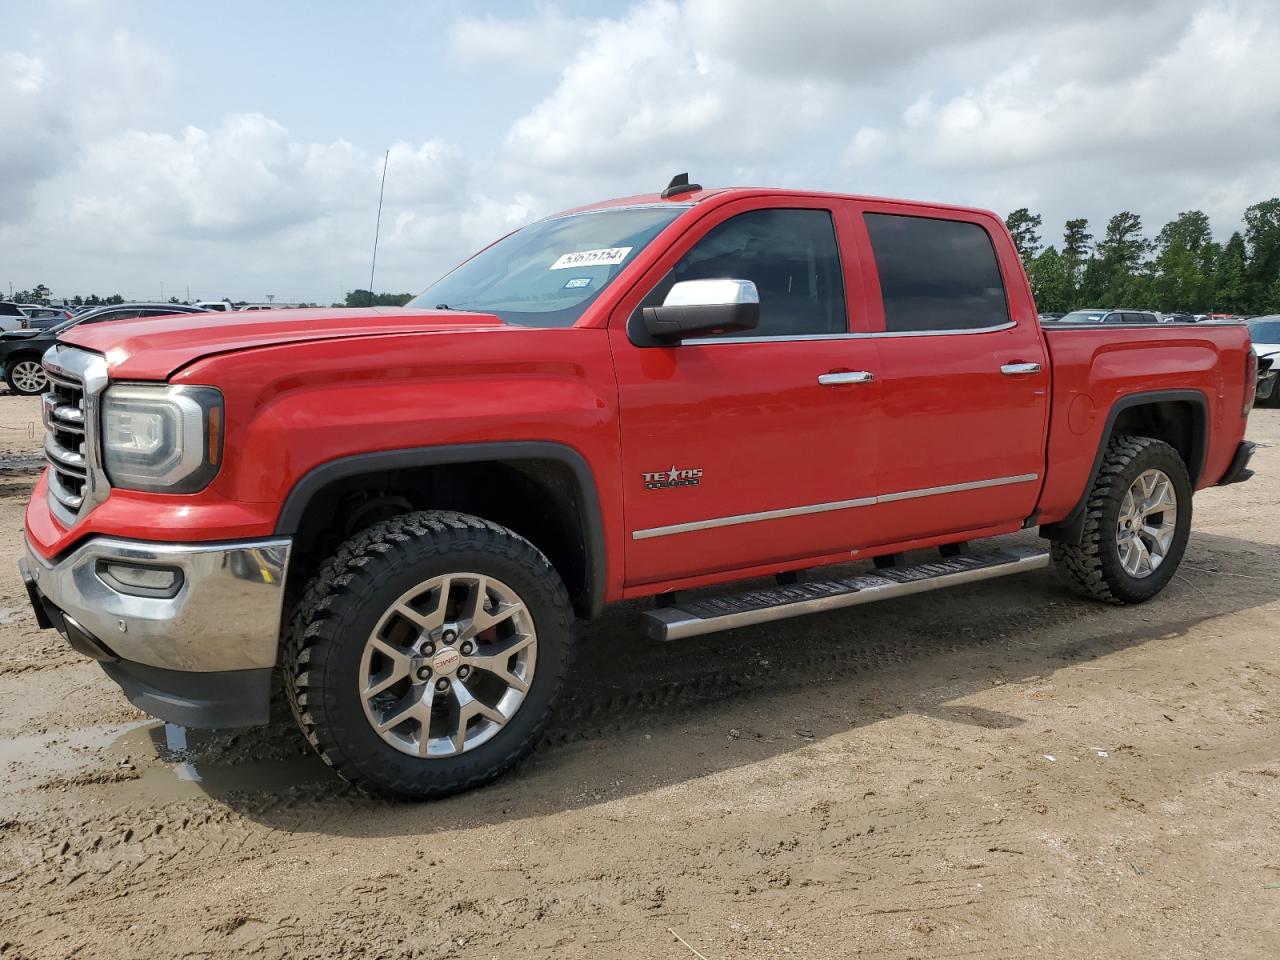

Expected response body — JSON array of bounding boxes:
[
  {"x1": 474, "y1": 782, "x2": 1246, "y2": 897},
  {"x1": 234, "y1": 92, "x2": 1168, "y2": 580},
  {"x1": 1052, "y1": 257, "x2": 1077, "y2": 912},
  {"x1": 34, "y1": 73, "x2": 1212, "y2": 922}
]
[{"x1": 20, "y1": 536, "x2": 291, "y2": 672}]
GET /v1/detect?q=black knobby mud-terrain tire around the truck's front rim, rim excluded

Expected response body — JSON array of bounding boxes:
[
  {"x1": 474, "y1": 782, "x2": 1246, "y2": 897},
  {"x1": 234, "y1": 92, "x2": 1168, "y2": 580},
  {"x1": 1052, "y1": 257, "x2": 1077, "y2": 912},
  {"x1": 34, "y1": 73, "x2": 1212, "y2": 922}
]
[{"x1": 284, "y1": 511, "x2": 573, "y2": 800}]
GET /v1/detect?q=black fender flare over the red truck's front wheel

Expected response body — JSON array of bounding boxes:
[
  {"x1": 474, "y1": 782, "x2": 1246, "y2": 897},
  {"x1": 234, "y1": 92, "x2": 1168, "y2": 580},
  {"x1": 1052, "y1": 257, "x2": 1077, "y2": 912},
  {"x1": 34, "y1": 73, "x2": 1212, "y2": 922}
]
[{"x1": 275, "y1": 440, "x2": 607, "y2": 618}]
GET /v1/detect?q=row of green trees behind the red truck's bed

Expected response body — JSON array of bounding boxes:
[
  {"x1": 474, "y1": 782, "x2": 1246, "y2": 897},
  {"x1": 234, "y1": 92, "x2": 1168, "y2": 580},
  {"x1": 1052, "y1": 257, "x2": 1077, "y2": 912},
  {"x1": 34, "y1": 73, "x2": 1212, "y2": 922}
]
[{"x1": 1005, "y1": 197, "x2": 1280, "y2": 315}]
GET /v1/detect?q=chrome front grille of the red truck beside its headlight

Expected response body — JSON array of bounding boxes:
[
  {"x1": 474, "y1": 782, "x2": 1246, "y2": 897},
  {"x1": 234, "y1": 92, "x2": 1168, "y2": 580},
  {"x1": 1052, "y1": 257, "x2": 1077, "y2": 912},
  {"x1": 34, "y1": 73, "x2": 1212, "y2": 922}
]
[{"x1": 42, "y1": 344, "x2": 108, "y2": 526}]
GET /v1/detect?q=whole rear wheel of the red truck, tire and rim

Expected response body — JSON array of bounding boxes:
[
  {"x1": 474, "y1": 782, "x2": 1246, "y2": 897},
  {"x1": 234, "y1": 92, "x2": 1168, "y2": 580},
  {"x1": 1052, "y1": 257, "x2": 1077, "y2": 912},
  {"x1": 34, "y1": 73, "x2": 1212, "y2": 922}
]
[{"x1": 1052, "y1": 436, "x2": 1192, "y2": 603}]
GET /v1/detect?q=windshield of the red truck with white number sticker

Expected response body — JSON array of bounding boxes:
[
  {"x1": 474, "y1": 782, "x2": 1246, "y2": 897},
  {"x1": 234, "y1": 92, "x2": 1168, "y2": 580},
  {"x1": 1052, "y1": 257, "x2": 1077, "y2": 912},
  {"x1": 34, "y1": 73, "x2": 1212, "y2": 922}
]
[{"x1": 408, "y1": 204, "x2": 689, "y2": 326}]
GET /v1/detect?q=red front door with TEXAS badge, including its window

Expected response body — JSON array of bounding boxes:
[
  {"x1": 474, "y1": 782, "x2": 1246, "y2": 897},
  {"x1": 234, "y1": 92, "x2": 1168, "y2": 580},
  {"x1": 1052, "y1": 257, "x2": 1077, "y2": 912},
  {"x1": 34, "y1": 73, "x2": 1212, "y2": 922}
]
[{"x1": 611, "y1": 200, "x2": 879, "y2": 586}]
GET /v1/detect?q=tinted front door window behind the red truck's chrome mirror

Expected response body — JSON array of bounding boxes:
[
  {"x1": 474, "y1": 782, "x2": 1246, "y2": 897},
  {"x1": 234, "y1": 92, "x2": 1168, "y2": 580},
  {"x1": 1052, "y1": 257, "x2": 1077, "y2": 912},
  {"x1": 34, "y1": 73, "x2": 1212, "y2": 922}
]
[{"x1": 646, "y1": 210, "x2": 849, "y2": 337}]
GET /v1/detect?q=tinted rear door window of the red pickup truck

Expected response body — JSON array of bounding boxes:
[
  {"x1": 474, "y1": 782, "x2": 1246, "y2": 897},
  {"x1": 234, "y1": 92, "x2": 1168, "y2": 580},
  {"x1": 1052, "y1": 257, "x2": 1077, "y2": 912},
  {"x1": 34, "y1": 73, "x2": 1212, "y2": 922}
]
[{"x1": 865, "y1": 214, "x2": 1009, "y2": 332}]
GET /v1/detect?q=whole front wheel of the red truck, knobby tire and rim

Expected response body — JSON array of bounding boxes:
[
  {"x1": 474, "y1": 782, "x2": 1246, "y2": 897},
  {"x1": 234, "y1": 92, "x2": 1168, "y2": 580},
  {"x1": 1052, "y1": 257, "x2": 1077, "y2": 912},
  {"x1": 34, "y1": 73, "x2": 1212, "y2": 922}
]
[{"x1": 285, "y1": 511, "x2": 573, "y2": 800}]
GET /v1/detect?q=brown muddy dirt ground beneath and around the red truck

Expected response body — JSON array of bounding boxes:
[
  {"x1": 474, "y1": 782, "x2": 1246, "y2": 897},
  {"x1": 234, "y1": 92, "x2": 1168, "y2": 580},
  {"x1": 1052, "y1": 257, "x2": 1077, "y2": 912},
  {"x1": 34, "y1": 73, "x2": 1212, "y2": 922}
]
[{"x1": 0, "y1": 397, "x2": 1280, "y2": 960}]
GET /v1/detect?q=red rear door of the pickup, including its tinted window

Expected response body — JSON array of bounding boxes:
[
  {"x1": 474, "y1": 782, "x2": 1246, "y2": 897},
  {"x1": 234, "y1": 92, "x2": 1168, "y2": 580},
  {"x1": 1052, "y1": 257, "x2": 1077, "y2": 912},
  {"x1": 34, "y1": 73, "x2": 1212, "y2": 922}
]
[{"x1": 852, "y1": 202, "x2": 1050, "y2": 543}]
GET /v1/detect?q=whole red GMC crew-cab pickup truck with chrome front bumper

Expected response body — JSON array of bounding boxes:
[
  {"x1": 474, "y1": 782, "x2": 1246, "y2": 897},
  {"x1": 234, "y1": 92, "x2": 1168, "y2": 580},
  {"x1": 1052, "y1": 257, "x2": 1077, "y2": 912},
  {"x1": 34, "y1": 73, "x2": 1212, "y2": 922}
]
[{"x1": 22, "y1": 178, "x2": 1256, "y2": 797}]
